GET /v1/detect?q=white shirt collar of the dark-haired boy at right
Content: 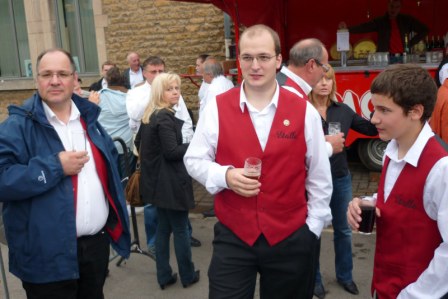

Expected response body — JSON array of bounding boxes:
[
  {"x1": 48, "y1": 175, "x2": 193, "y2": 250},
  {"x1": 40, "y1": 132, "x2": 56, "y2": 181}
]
[{"x1": 385, "y1": 123, "x2": 434, "y2": 167}]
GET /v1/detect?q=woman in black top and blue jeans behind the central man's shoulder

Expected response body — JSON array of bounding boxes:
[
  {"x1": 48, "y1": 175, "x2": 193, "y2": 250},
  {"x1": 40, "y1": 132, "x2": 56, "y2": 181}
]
[{"x1": 309, "y1": 67, "x2": 378, "y2": 299}]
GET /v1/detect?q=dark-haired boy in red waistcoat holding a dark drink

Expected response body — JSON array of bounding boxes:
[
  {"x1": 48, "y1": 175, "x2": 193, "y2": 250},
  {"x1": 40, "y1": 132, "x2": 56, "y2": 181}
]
[{"x1": 347, "y1": 65, "x2": 448, "y2": 299}]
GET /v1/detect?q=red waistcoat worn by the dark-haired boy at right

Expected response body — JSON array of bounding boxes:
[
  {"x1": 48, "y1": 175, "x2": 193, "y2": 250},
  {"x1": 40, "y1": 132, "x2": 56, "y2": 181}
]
[{"x1": 372, "y1": 137, "x2": 447, "y2": 299}]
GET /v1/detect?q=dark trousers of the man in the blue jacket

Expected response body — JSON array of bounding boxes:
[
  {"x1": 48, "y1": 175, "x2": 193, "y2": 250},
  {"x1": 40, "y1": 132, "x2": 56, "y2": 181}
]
[{"x1": 22, "y1": 231, "x2": 110, "y2": 299}]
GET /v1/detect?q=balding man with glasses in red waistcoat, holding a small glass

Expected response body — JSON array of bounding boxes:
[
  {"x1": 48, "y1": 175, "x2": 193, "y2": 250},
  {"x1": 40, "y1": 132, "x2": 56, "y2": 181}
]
[{"x1": 184, "y1": 25, "x2": 332, "y2": 299}]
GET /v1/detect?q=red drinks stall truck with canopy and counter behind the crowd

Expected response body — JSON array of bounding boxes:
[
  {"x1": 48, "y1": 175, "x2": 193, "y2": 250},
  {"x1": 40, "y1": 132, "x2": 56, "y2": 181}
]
[{"x1": 174, "y1": 0, "x2": 448, "y2": 171}]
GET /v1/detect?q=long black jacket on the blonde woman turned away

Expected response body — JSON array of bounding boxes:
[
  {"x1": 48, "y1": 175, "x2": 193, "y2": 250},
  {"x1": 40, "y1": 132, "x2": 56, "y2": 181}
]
[{"x1": 135, "y1": 109, "x2": 194, "y2": 211}]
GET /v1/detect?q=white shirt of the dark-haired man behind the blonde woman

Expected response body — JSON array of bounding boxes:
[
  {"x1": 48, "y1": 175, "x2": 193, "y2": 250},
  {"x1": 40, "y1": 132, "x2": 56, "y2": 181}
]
[{"x1": 126, "y1": 81, "x2": 193, "y2": 140}]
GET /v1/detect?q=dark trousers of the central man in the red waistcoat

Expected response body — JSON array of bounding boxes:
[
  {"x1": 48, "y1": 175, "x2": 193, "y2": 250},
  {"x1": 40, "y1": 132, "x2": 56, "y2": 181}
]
[{"x1": 208, "y1": 222, "x2": 318, "y2": 299}]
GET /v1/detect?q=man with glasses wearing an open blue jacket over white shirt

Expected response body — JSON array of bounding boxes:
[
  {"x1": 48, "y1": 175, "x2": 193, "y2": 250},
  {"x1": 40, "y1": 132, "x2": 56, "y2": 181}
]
[{"x1": 0, "y1": 49, "x2": 130, "y2": 299}]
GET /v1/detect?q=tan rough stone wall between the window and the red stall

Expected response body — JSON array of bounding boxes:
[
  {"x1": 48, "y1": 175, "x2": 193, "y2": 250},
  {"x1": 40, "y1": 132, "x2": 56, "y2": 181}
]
[{"x1": 103, "y1": 0, "x2": 225, "y2": 117}]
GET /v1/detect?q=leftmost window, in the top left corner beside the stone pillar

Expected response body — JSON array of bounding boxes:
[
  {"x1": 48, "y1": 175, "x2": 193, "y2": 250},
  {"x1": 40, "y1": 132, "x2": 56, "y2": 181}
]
[{"x1": 0, "y1": 0, "x2": 33, "y2": 77}]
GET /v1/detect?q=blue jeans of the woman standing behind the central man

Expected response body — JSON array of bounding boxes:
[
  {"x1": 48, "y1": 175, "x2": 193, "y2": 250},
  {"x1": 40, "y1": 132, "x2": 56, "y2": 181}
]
[{"x1": 316, "y1": 174, "x2": 353, "y2": 284}]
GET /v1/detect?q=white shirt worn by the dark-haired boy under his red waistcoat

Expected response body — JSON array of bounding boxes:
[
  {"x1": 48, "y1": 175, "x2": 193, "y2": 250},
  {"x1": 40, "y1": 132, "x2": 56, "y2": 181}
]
[{"x1": 384, "y1": 123, "x2": 448, "y2": 299}]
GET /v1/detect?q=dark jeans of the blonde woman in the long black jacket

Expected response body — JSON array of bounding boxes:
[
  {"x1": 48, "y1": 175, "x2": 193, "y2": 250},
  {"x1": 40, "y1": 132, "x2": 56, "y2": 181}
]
[{"x1": 156, "y1": 208, "x2": 195, "y2": 284}]
